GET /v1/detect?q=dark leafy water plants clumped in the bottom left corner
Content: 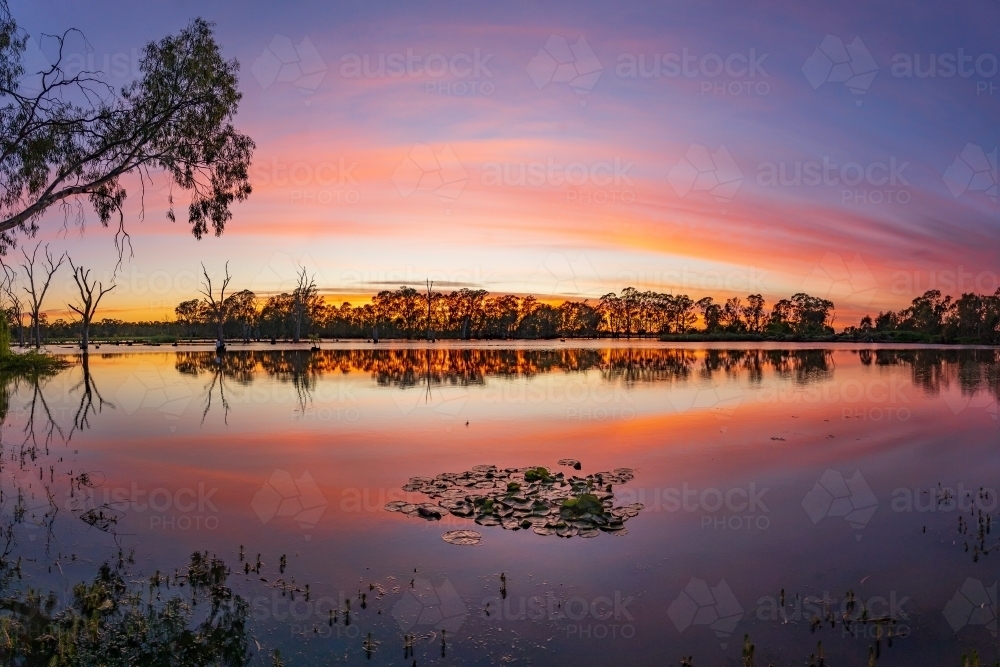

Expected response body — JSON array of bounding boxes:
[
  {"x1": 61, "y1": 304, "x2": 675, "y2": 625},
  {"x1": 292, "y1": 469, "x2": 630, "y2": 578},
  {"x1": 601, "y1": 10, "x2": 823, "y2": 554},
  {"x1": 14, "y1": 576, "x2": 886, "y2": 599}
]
[{"x1": 0, "y1": 553, "x2": 250, "y2": 667}]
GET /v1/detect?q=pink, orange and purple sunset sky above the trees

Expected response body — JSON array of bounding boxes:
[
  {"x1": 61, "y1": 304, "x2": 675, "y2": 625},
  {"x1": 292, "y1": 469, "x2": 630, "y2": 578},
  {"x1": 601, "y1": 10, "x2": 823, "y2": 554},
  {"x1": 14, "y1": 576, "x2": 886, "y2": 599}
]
[{"x1": 5, "y1": 0, "x2": 1000, "y2": 329}]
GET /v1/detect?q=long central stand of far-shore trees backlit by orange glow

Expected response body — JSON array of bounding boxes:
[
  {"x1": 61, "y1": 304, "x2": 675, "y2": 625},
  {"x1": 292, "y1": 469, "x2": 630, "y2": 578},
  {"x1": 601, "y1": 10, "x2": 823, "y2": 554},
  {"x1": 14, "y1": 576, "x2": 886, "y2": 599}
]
[{"x1": 160, "y1": 280, "x2": 834, "y2": 342}]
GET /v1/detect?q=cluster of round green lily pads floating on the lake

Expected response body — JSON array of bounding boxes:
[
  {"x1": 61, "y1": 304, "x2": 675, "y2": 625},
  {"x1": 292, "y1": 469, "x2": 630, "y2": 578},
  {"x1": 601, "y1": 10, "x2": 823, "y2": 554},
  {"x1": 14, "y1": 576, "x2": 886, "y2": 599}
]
[{"x1": 385, "y1": 459, "x2": 643, "y2": 543}]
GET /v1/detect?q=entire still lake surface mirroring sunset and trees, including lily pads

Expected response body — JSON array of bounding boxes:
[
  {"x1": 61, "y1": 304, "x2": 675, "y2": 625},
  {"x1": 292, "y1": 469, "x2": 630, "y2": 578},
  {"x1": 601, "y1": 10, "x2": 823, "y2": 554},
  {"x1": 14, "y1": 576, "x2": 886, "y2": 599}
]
[{"x1": 2, "y1": 342, "x2": 1000, "y2": 666}]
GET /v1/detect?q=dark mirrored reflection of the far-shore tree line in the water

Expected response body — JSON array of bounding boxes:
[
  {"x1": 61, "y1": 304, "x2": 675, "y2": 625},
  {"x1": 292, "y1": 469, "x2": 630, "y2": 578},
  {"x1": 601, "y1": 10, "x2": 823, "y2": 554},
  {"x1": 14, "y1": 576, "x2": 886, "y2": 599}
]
[{"x1": 160, "y1": 347, "x2": 1000, "y2": 407}]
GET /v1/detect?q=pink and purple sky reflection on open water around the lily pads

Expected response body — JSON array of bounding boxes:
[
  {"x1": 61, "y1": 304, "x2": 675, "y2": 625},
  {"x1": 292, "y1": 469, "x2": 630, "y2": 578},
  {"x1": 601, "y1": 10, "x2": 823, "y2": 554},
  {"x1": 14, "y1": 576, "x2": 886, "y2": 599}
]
[{"x1": 4, "y1": 346, "x2": 1000, "y2": 664}]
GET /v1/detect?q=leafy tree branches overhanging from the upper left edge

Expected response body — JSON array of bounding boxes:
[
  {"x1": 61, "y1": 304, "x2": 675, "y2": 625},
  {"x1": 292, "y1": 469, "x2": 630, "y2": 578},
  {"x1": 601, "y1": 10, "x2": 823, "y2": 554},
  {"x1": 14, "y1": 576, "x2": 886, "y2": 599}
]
[{"x1": 0, "y1": 7, "x2": 254, "y2": 260}]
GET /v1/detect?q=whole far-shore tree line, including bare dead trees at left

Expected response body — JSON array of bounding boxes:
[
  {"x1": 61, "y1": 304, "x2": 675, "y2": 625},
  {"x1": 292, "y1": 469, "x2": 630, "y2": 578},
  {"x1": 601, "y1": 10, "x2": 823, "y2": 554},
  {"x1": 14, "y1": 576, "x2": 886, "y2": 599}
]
[{"x1": 11, "y1": 256, "x2": 1000, "y2": 349}]
